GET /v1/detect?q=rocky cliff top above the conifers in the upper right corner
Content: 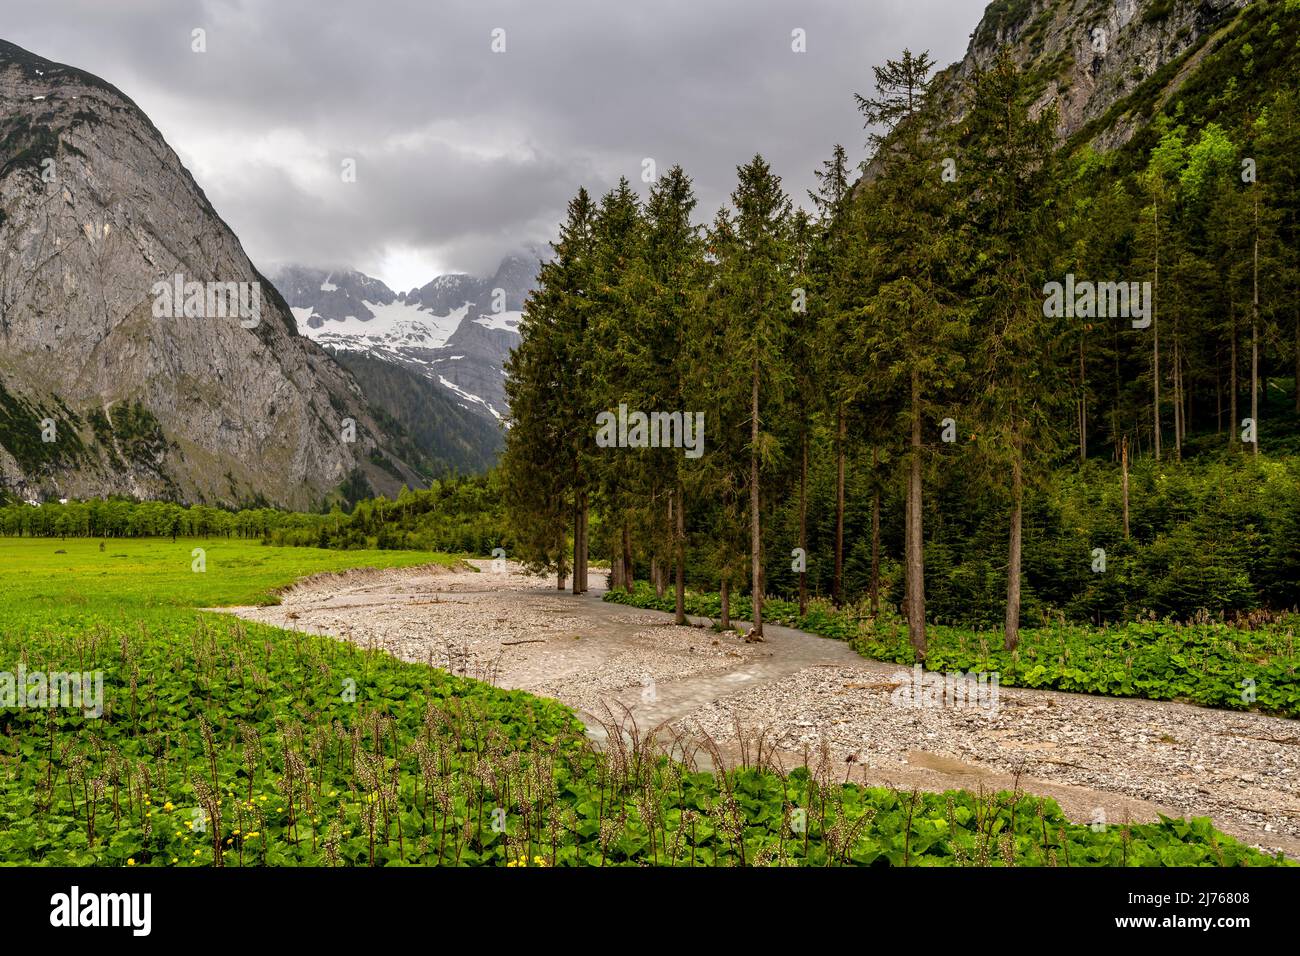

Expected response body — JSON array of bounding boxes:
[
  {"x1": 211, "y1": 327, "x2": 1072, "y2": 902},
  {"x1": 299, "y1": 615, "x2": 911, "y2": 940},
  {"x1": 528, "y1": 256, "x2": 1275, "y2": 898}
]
[{"x1": 939, "y1": 0, "x2": 1262, "y2": 150}]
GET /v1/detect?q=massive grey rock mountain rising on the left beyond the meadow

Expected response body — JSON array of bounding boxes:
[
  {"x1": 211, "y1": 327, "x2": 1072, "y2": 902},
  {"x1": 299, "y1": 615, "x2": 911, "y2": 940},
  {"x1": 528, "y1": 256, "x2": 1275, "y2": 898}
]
[{"x1": 0, "y1": 42, "x2": 416, "y2": 506}]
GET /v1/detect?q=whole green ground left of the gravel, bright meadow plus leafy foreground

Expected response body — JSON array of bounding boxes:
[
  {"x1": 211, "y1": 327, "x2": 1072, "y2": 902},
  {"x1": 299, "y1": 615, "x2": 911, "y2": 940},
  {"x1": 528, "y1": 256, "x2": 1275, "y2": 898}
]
[{"x1": 0, "y1": 538, "x2": 1277, "y2": 866}]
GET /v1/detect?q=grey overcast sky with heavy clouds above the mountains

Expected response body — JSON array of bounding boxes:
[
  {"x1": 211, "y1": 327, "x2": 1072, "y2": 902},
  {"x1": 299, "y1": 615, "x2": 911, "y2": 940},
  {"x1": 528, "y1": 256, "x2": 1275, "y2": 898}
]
[{"x1": 0, "y1": 0, "x2": 984, "y2": 290}]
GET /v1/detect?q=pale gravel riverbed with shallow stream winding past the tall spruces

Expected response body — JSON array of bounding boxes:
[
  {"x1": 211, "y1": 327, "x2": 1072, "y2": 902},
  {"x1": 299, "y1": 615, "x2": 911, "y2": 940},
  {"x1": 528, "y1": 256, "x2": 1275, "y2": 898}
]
[{"x1": 228, "y1": 561, "x2": 1300, "y2": 857}]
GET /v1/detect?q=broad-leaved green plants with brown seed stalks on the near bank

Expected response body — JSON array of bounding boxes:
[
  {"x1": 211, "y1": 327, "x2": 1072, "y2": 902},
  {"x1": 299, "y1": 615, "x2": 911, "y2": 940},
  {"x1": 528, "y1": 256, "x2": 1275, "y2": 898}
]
[{"x1": 0, "y1": 587, "x2": 1274, "y2": 866}]
